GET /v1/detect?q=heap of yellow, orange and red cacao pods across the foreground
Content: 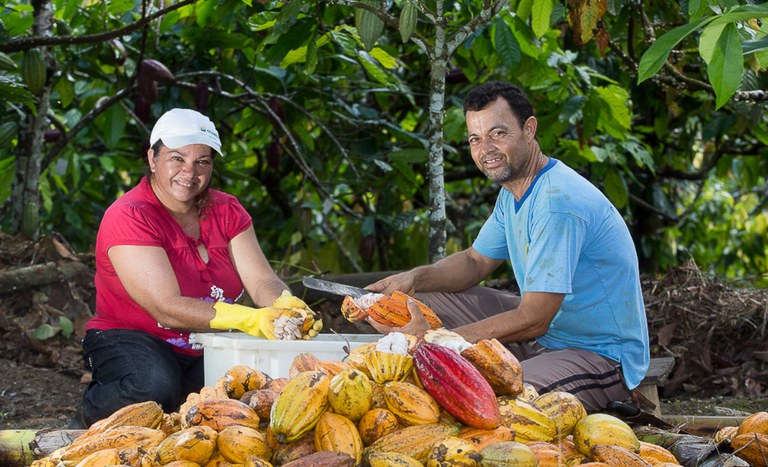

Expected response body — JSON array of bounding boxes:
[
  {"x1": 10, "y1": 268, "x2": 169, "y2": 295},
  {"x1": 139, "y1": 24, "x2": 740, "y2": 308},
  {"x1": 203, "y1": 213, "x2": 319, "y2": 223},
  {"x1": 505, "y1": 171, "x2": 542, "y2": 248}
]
[{"x1": 33, "y1": 333, "x2": 768, "y2": 467}]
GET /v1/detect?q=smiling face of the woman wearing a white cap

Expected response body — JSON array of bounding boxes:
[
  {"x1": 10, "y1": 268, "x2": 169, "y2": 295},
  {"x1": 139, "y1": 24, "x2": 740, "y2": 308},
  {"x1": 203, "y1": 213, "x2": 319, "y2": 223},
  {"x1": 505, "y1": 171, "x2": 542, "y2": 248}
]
[{"x1": 147, "y1": 144, "x2": 213, "y2": 205}]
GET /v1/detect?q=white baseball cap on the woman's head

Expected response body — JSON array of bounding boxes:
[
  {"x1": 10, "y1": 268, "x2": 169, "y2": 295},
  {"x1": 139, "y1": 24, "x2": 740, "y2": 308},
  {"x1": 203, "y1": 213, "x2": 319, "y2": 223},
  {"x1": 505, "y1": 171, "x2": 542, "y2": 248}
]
[{"x1": 149, "y1": 109, "x2": 224, "y2": 156}]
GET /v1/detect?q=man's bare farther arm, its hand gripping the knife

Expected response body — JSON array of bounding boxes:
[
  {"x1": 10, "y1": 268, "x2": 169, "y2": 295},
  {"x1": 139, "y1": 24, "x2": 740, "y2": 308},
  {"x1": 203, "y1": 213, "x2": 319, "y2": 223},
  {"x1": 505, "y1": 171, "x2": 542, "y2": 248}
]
[{"x1": 366, "y1": 247, "x2": 504, "y2": 295}]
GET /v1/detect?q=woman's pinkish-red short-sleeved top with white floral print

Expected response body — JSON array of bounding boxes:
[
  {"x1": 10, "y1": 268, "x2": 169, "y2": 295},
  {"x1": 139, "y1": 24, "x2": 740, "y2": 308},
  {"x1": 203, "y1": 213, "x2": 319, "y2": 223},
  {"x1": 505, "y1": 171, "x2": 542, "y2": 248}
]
[{"x1": 86, "y1": 177, "x2": 252, "y2": 355}]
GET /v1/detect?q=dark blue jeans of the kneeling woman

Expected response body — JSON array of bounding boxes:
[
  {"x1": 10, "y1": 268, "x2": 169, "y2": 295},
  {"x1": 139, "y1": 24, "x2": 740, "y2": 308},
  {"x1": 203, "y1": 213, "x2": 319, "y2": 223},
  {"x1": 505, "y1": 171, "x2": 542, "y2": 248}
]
[{"x1": 80, "y1": 329, "x2": 204, "y2": 426}]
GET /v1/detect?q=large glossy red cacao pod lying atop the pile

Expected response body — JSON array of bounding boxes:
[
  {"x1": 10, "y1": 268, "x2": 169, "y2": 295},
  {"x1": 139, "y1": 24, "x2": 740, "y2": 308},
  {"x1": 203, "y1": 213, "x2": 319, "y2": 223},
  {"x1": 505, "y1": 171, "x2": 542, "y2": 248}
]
[{"x1": 413, "y1": 342, "x2": 501, "y2": 430}]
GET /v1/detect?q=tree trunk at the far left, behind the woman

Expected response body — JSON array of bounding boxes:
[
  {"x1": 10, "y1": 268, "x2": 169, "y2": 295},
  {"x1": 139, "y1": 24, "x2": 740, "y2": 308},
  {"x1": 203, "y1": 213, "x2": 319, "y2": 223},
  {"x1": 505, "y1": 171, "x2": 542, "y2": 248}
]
[{"x1": 10, "y1": 0, "x2": 53, "y2": 239}]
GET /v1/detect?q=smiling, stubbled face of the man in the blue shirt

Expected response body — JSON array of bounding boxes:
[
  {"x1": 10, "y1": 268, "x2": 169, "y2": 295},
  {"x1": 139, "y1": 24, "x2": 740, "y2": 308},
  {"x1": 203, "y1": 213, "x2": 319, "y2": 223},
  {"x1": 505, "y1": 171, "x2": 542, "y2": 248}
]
[{"x1": 466, "y1": 97, "x2": 536, "y2": 184}]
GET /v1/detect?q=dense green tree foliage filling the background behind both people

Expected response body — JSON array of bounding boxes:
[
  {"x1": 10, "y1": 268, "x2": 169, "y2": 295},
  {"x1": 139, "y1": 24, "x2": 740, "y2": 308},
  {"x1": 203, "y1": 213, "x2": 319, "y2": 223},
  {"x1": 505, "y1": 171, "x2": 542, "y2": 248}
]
[{"x1": 0, "y1": 0, "x2": 768, "y2": 286}]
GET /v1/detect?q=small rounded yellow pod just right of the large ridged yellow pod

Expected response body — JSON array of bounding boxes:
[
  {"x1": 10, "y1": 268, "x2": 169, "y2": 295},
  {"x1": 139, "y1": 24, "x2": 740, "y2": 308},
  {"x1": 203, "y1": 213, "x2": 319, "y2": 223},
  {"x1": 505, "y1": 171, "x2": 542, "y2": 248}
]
[{"x1": 328, "y1": 369, "x2": 373, "y2": 422}]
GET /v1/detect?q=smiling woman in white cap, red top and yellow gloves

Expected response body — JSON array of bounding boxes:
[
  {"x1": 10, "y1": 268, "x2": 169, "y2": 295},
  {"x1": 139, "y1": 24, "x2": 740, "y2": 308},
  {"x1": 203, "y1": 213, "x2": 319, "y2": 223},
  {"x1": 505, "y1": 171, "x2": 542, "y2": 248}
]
[{"x1": 70, "y1": 109, "x2": 322, "y2": 427}]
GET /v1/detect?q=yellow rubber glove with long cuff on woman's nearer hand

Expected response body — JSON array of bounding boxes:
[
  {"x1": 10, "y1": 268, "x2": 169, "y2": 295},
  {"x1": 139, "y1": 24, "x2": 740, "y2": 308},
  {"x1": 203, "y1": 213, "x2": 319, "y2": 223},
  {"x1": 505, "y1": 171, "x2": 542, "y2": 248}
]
[{"x1": 209, "y1": 302, "x2": 312, "y2": 340}]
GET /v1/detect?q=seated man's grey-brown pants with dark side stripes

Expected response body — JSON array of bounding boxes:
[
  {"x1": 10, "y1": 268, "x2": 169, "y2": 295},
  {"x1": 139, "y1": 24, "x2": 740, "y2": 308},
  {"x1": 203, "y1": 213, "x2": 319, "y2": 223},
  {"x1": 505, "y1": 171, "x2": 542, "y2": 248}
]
[{"x1": 416, "y1": 287, "x2": 631, "y2": 411}]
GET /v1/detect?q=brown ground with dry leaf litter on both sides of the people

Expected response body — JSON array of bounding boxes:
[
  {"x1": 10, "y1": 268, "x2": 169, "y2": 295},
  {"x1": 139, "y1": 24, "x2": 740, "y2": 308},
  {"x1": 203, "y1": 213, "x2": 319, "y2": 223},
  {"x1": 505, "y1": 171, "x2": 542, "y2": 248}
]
[{"x1": 0, "y1": 234, "x2": 768, "y2": 429}]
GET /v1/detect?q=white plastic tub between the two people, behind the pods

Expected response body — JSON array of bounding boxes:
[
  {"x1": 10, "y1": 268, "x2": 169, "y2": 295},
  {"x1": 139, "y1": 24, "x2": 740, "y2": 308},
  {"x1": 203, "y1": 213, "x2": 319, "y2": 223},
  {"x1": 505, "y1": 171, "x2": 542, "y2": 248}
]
[{"x1": 195, "y1": 332, "x2": 383, "y2": 386}]
